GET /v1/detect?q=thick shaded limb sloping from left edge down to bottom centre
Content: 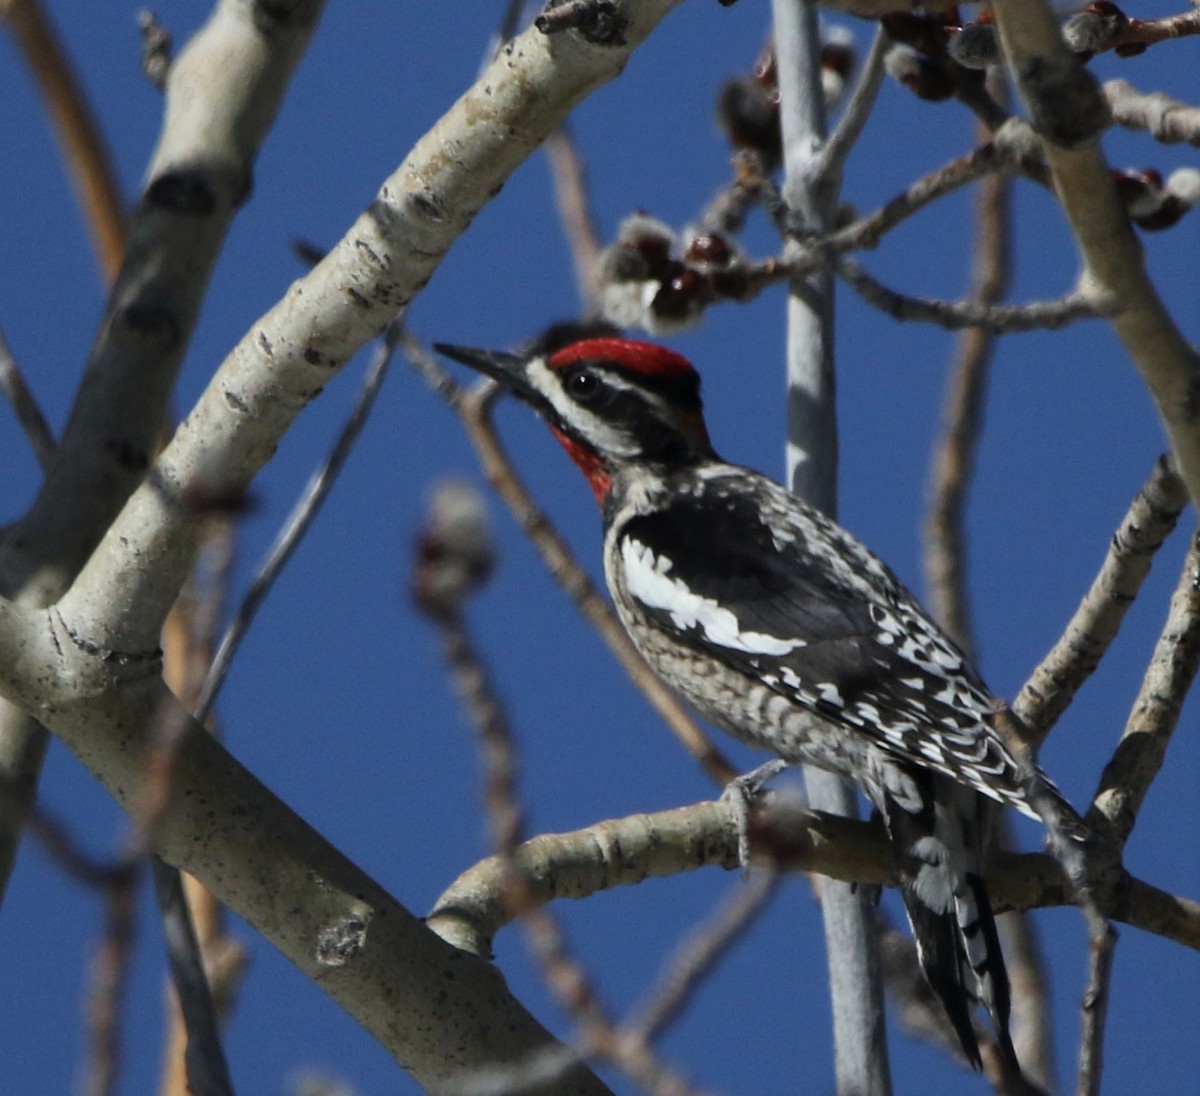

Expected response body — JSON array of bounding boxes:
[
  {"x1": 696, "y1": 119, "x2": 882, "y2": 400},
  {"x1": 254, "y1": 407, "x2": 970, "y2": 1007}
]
[{"x1": 0, "y1": 603, "x2": 607, "y2": 1094}]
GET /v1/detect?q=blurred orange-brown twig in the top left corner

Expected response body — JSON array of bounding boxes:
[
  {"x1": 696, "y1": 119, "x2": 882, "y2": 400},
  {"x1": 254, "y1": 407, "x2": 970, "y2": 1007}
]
[{"x1": 0, "y1": 0, "x2": 125, "y2": 282}]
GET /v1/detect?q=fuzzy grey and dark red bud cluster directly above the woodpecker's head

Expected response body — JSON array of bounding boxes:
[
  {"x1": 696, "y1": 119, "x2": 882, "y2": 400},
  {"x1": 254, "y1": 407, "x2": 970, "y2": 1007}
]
[{"x1": 600, "y1": 212, "x2": 746, "y2": 335}]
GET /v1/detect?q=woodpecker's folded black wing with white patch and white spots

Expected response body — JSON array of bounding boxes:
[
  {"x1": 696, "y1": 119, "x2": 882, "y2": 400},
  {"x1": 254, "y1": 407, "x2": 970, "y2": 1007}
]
[{"x1": 618, "y1": 479, "x2": 1027, "y2": 809}]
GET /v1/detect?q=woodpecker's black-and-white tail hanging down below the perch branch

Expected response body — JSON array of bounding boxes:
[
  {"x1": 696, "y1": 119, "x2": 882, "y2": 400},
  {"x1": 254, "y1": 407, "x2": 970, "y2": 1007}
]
[{"x1": 883, "y1": 777, "x2": 1016, "y2": 1070}]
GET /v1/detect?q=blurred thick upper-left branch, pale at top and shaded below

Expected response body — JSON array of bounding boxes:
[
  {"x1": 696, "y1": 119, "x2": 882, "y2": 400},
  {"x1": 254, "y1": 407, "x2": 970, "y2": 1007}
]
[{"x1": 0, "y1": 0, "x2": 323, "y2": 907}]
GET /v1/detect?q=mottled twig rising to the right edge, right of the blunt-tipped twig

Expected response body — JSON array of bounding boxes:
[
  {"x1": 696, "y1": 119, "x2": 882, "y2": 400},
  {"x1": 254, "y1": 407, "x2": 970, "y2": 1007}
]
[{"x1": 1086, "y1": 535, "x2": 1200, "y2": 848}]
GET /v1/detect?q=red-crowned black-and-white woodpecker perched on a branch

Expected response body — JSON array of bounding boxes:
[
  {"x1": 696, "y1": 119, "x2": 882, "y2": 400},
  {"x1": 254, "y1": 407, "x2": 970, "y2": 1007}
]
[{"x1": 437, "y1": 339, "x2": 1037, "y2": 1068}]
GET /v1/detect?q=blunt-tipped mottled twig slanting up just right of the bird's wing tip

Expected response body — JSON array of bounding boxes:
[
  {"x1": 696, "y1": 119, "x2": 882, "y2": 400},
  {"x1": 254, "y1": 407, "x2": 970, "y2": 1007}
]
[{"x1": 1013, "y1": 457, "x2": 1188, "y2": 742}]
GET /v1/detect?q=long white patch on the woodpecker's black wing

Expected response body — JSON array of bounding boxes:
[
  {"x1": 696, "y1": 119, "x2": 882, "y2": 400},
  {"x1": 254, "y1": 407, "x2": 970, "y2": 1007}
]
[{"x1": 620, "y1": 537, "x2": 805, "y2": 654}]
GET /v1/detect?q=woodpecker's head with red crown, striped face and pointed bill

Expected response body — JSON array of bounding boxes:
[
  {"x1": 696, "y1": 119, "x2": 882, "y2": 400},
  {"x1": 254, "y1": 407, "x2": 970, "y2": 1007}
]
[{"x1": 434, "y1": 339, "x2": 713, "y2": 505}]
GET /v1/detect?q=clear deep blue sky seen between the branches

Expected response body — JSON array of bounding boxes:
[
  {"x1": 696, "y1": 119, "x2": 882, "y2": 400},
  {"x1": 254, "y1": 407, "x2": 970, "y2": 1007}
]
[{"x1": 0, "y1": 0, "x2": 1200, "y2": 1096}]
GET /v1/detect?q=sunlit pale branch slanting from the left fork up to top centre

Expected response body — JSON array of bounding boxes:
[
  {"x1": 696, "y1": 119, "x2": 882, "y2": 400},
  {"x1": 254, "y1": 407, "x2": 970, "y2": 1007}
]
[{"x1": 54, "y1": 0, "x2": 678, "y2": 651}]
